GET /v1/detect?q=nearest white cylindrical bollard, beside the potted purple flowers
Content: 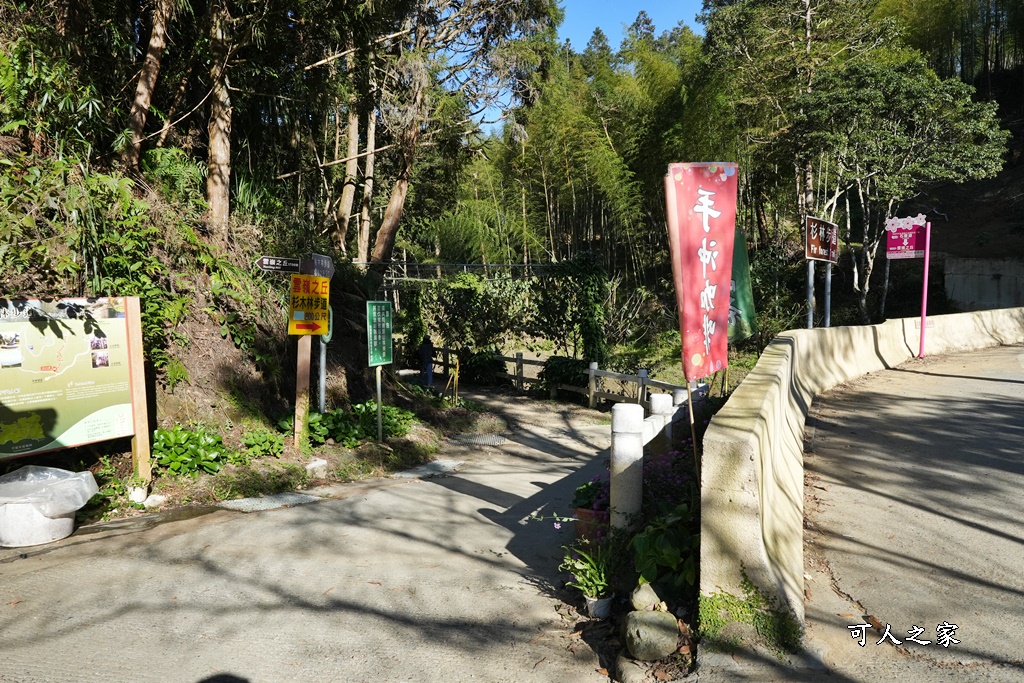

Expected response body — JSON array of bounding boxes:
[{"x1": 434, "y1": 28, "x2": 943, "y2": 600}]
[{"x1": 609, "y1": 403, "x2": 644, "y2": 528}]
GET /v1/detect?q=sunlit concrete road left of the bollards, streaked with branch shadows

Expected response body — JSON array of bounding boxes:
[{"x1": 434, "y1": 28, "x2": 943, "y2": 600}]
[{"x1": 0, "y1": 398, "x2": 609, "y2": 683}]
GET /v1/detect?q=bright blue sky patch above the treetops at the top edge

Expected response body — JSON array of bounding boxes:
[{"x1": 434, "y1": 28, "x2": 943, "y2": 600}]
[{"x1": 558, "y1": 0, "x2": 703, "y2": 52}]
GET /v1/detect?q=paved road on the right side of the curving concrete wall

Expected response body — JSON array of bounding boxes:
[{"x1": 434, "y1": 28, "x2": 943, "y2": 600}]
[{"x1": 700, "y1": 346, "x2": 1024, "y2": 683}]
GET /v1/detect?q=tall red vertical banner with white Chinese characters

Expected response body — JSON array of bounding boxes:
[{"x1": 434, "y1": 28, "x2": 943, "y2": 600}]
[{"x1": 665, "y1": 162, "x2": 737, "y2": 380}]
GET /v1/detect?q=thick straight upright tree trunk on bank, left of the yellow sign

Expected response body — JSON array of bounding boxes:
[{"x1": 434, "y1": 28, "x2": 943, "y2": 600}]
[{"x1": 206, "y1": 0, "x2": 231, "y2": 238}]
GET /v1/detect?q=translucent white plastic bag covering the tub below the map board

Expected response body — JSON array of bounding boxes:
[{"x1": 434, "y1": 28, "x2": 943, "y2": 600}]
[{"x1": 0, "y1": 465, "x2": 99, "y2": 517}]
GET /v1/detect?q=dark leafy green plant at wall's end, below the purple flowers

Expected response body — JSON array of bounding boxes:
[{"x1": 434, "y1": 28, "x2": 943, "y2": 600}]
[{"x1": 633, "y1": 503, "x2": 700, "y2": 600}]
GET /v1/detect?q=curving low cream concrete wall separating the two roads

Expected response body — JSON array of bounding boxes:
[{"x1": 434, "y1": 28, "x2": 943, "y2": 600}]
[{"x1": 700, "y1": 308, "x2": 1024, "y2": 623}]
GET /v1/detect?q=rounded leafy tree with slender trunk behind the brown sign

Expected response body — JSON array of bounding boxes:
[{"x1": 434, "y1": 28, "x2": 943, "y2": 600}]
[{"x1": 797, "y1": 54, "x2": 1008, "y2": 322}]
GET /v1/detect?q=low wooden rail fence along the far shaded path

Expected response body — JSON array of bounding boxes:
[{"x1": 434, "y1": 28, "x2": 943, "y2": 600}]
[{"x1": 434, "y1": 347, "x2": 686, "y2": 408}]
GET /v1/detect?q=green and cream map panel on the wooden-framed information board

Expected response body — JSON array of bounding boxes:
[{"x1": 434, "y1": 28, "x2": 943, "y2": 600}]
[{"x1": 0, "y1": 298, "x2": 133, "y2": 459}]
